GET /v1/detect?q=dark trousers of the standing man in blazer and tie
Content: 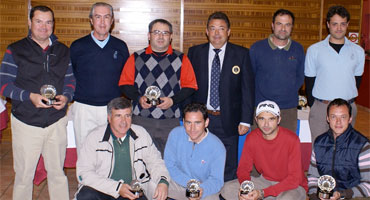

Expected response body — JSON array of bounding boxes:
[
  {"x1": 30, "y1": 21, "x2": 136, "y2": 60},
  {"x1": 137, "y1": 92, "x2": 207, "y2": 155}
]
[{"x1": 208, "y1": 115, "x2": 239, "y2": 182}]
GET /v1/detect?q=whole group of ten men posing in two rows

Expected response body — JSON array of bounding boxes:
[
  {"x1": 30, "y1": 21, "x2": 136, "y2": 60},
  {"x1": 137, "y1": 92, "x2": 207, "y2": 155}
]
[{"x1": 0, "y1": 2, "x2": 370, "y2": 200}]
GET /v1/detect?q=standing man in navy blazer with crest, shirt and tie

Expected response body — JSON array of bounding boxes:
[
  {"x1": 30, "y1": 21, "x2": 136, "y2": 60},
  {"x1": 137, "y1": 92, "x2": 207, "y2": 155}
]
[{"x1": 188, "y1": 12, "x2": 254, "y2": 182}]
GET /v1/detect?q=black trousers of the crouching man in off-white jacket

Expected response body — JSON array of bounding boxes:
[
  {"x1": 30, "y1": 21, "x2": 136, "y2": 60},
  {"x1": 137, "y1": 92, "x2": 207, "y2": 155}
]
[{"x1": 76, "y1": 186, "x2": 147, "y2": 200}]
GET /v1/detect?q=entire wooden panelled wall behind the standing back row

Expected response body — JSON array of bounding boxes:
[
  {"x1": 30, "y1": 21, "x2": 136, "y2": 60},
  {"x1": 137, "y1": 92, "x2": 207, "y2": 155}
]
[{"x1": 0, "y1": 0, "x2": 362, "y2": 62}]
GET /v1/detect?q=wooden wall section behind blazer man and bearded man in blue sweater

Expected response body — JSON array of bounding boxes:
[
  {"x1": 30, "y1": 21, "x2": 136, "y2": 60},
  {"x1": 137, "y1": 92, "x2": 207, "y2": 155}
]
[{"x1": 184, "y1": 0, "x2": 321, "y2": 51}]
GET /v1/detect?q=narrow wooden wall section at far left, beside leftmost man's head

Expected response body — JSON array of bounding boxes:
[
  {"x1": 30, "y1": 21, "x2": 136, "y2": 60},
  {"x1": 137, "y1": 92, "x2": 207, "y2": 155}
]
[{"x1": 0, "y1": 0, "x2": 28, "y2": 60}]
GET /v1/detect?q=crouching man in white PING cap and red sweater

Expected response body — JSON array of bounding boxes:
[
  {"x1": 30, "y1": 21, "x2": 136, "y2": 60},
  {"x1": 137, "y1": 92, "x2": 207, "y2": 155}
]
[{"x1": 224, "y1": 100, "x2": 307, "y2": 200}]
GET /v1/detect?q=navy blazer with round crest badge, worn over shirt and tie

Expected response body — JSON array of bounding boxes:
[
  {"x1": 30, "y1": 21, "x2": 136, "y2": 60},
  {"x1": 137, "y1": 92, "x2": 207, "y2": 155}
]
[{"x1": 188, "y1": 42, "x2": 254, "y2": 136}]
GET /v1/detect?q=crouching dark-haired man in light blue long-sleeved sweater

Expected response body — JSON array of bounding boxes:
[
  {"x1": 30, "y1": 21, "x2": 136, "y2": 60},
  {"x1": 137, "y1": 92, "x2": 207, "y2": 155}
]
[{"x1": 164, "y1": 103, "x2": 226, "y2": 200}]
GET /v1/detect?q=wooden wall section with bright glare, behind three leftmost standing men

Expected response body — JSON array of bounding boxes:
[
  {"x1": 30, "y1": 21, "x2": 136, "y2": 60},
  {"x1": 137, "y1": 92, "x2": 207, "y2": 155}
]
[{"x1": 31, "y1": 0, "x2": 181, "y2": 53}]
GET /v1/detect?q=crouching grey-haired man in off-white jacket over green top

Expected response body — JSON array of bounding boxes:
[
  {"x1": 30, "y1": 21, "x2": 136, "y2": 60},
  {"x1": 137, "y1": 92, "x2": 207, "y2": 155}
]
[{"x1": 76, "y1": 97, "x2": 169, "y2": 200}]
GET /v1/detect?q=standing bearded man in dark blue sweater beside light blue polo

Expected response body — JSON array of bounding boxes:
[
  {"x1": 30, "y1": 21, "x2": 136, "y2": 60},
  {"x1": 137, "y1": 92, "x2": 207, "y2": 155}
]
[{"x1": 250, "y1": 9, "x2": 305, "y2": 132}]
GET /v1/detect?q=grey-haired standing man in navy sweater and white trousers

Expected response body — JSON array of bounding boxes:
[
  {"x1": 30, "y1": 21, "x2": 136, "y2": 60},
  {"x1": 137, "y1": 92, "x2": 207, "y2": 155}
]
[{"x1": 71, "y1": 2, "x2": 129, "y2": 155}]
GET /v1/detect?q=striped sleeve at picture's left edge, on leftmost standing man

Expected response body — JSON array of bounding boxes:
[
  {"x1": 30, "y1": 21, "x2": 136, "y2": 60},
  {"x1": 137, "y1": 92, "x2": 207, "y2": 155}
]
[{"x1": 0, "y1": 48, "x2": 30, "y2": 101}]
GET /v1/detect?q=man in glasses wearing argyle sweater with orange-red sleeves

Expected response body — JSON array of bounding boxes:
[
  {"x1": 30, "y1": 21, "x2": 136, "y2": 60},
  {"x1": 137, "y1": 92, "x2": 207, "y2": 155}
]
[{"x1": 119, "y1": 19, "x2": 198, "y2": 155}]
